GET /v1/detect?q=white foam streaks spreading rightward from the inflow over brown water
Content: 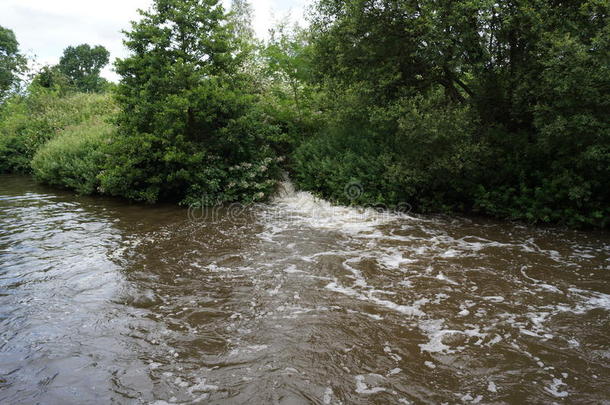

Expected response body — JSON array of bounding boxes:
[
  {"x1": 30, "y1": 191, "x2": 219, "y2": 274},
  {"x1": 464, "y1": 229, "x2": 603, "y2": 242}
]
[{"x1": 249, "y1": 178, "x2": 610, "y2": 403}]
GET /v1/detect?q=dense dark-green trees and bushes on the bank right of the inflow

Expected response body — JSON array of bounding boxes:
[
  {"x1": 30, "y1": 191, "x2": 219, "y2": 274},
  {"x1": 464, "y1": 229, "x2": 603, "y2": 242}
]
[{"x1": 296, "y1": 0, "x2": 610, "y2": 227}]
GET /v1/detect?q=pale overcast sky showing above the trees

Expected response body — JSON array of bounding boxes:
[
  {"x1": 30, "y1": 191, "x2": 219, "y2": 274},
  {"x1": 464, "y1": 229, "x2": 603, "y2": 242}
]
[{"x1": 0, "y1": 0, "x2": 309, "y2": 80}]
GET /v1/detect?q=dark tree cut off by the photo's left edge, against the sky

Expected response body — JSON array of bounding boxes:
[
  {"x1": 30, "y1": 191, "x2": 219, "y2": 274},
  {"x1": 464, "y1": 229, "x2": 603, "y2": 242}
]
[{"x1": 0, "y1": 26, "x2": 26, "y2": 101}]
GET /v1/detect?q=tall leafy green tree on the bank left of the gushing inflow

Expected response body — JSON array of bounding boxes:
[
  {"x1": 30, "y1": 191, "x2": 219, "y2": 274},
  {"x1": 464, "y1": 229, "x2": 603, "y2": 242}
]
[{"x1": 102, "y1": 0, "x2": 280, "y2": 203}]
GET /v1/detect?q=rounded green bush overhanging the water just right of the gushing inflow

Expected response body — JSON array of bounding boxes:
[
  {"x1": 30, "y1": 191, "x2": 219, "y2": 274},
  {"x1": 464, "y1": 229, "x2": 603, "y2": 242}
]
[{"x1": 293, "y1": 91, "x2": 485, "y2": 211}]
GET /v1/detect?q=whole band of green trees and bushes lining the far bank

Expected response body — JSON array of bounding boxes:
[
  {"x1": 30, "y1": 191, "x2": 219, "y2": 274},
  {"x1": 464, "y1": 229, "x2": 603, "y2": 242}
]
[{"x1": 0, "y1": 0, "x2": 610, "y2": 228}]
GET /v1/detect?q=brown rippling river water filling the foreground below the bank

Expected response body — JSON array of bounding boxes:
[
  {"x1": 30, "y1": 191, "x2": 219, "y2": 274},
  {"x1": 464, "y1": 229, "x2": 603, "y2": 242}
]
[{"x1": 0, "y1": 176, "x2": 610, "y2": 404}]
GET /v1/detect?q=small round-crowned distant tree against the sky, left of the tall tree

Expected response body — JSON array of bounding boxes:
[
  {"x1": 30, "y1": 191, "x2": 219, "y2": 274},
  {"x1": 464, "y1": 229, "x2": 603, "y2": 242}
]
[{"x1": 59, "y1": 44, "x2": 110, "y2": 93}]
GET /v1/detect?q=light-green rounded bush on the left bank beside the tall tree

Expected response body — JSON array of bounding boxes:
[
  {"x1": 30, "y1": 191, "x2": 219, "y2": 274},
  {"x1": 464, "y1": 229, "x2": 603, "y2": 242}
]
[{"x1": 31, "y1": 117, "x2": 115, "y2": 194}]
